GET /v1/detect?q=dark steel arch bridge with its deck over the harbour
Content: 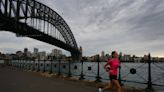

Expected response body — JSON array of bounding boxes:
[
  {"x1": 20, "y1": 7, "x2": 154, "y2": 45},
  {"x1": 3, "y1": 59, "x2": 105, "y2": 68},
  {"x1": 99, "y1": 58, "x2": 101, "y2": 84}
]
[{"x1": 0, "y1": 0, "x2": 81, "y2": 57}]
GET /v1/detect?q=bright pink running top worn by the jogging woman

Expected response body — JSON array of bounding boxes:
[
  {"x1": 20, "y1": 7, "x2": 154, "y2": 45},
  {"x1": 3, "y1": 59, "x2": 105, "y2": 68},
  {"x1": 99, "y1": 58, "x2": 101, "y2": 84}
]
[{"x1": 107, "y1": 59, "x2": 120, "y2": 76}]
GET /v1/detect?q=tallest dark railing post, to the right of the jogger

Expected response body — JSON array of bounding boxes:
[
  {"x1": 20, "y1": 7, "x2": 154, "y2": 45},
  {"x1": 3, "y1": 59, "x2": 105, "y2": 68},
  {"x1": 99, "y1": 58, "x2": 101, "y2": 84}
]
[{"x1": 146, "y1": 53, "x2": 154, "y2": 92}]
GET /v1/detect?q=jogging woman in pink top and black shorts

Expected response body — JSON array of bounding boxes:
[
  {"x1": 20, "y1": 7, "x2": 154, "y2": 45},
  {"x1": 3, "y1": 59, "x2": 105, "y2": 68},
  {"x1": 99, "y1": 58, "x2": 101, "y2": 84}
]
[{"x1": 99, "y1": 51, "x2": 121, "y2": 92}]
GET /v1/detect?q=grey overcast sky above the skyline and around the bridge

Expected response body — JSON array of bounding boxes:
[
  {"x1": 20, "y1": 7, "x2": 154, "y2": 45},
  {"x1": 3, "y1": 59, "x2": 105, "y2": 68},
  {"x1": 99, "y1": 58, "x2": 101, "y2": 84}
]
[{"x1": 0, "y1": 0, "x2": 164, "y2": 56}]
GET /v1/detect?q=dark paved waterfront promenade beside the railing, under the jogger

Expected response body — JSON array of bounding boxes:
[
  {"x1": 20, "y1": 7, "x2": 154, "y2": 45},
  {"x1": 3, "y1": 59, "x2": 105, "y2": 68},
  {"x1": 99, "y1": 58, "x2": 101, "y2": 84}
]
[{"x1": 0, "y1": 66, "x2": 143, "y2": 92}]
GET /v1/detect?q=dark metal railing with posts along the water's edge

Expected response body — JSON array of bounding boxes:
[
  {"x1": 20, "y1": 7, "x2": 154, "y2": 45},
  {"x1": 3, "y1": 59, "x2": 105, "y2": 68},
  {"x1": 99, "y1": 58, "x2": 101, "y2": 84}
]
[{"x1": 10, "y1": 55, "x2": 164, "y2": 90}]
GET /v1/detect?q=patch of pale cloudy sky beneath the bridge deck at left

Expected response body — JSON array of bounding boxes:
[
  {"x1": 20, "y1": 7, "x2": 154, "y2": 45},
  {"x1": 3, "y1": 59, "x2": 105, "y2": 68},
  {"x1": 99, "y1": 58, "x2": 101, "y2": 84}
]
[{"x1": 0, "y1": 32, "x2": 54, "y2": 53}]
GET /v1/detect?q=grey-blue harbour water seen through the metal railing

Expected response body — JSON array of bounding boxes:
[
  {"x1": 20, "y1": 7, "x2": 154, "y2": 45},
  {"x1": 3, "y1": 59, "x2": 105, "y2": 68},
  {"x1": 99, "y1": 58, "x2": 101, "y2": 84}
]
[{"x1": 13, "y1": 61, "x2": 164, "y2": 92}]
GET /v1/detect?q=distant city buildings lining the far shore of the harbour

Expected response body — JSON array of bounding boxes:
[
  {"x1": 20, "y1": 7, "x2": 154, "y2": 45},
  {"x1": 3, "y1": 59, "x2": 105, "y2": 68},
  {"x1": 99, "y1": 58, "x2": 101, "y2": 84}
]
[{"x1": 0, "y1": 48, "x2": 164, "y2": 63}]
